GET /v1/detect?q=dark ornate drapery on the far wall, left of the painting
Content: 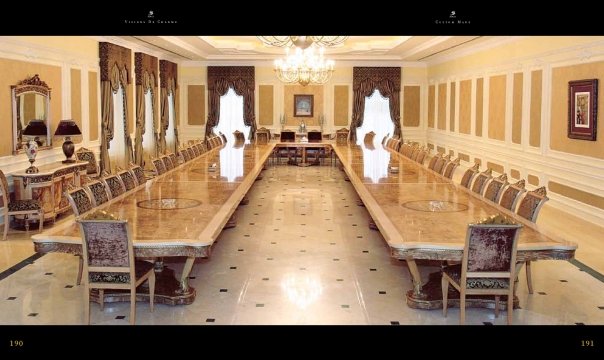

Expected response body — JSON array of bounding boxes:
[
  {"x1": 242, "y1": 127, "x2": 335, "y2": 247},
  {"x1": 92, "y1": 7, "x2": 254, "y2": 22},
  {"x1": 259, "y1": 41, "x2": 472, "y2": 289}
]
[{"x1": 206, "y1": 66, "x2": 256, "y2": 140}]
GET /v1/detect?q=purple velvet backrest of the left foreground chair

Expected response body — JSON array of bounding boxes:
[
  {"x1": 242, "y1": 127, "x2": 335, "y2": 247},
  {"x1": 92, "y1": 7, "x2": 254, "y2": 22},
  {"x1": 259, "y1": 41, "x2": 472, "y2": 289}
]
[{"x1": 77, "y1": 219, "x2": 136, "y2": 284}]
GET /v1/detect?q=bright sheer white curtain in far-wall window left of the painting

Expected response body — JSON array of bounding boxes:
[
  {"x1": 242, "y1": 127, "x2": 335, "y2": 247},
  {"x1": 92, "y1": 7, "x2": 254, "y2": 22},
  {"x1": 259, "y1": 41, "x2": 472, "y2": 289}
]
[{"x1": 214, "y1": 88, "x2": 250, "y2": 144}]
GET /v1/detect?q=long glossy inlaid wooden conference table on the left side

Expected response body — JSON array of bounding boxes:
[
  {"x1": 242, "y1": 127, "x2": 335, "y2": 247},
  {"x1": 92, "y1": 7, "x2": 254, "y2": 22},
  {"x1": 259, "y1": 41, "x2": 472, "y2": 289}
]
[{"x1": 32, "y1": 143, "x2": 275, "y2": 305}]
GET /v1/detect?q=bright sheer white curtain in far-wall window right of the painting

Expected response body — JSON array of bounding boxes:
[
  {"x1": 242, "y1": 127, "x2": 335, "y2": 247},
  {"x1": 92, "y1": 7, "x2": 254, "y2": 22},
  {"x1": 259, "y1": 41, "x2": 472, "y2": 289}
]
[{"x1": 357, "y1": 89, "x2": 394, "y2": 145}]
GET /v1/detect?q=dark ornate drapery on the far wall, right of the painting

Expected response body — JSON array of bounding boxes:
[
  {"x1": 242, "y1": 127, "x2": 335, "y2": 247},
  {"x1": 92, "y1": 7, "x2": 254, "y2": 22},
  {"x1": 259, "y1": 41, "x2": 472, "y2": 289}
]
[{"x1": 350, "y1": 67, "x2": 402, "y2": 142}]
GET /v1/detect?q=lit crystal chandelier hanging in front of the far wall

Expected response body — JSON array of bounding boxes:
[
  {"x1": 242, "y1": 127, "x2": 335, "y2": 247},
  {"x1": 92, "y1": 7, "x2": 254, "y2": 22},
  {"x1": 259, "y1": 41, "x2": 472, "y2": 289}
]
[{"x1": 275, "y1": 46, "x2": 335, "y2": 86}]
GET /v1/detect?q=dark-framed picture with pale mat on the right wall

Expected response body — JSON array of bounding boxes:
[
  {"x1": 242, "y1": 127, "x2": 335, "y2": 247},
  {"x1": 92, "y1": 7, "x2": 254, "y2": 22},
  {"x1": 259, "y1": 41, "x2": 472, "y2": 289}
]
[{"x1": 568, "y1": 79, "x2": 598, "y2": 141}]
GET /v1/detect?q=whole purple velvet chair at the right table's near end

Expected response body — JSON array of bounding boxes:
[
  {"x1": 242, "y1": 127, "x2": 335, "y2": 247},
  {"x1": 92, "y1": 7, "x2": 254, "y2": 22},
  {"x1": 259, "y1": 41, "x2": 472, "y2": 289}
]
[{"x1": 441, "y1": 215, "x2": 522, "y2": 325}]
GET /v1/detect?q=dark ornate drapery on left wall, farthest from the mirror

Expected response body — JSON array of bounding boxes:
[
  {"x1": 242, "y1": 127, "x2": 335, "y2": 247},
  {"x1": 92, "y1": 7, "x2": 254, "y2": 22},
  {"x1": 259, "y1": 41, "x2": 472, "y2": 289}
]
[{"x1": 159, "y1": 60, "x2": 180, "y2": 153}]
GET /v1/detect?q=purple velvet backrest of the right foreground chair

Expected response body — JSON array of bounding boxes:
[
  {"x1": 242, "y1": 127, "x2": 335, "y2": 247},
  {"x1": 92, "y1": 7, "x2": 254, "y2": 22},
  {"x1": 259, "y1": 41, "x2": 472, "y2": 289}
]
[{"x1": 461, "y1": 224, "x2": 522, "y2": 287}]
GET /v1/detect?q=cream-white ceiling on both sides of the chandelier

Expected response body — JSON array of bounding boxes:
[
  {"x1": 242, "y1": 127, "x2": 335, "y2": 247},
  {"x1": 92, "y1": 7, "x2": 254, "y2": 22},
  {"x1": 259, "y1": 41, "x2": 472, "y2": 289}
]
[{"x1": 115, "y1": 36, "x2": 493, "y2": 62}]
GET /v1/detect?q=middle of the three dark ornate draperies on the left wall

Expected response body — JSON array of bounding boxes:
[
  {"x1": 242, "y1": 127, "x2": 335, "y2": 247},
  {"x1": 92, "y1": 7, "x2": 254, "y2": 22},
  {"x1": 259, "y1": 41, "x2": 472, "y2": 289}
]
[{"x1": 134, "y1": 52, "x2": 159, "y2": 166}]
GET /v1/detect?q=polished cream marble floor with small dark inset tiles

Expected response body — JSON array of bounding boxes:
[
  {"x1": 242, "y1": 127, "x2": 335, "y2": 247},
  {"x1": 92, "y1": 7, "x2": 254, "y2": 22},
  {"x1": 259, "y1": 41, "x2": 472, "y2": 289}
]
[{"x1": 0, "y1": 165, "x2": 604, "y2": 325}]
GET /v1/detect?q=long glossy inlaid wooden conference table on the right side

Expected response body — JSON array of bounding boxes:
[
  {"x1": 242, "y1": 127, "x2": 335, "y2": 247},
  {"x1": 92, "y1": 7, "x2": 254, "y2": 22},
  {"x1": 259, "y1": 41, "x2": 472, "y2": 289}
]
[{"x1": 333, "y1": 145, "x2": 577, "y2": 309}]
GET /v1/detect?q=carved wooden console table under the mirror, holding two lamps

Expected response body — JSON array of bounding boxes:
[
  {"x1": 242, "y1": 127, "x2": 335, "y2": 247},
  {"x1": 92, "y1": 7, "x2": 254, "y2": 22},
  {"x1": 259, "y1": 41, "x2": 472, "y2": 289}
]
[{"x1": 12, "y1": 161, "x2": 88, "y2": 221}]
